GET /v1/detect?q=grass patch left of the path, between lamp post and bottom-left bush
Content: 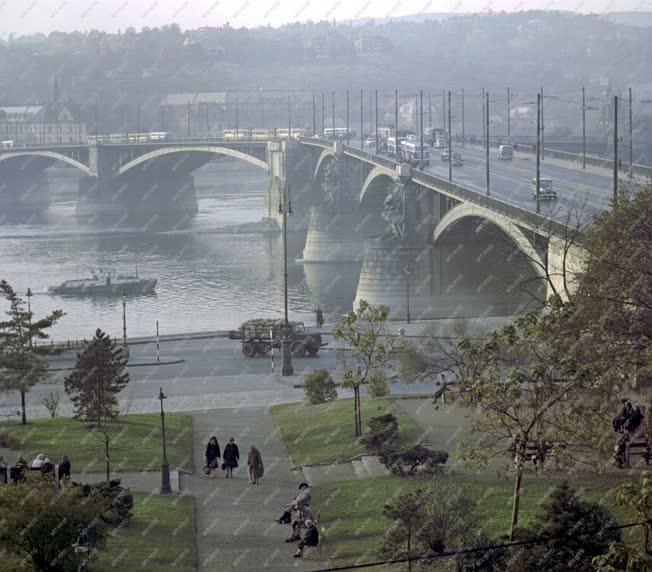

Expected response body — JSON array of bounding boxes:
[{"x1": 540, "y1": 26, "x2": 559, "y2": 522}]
[{"x1": 95, "y1": 494, "x2": 197, "y2": 572}]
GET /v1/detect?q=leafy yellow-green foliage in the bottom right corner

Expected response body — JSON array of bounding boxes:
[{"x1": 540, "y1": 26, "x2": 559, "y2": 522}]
[{"x1": 593, "y1": 471, "x2": 652, "y2": 572}]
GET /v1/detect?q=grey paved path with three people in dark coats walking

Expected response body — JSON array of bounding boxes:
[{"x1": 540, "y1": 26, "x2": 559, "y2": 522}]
[{"x1": 182, "y1": 407, "x2": 326, "y2": 572}]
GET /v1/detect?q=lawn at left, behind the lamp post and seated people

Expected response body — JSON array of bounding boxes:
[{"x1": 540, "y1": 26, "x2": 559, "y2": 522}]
[{"x1": 0, "y1": 413, "x2": 193, "y2": 472}]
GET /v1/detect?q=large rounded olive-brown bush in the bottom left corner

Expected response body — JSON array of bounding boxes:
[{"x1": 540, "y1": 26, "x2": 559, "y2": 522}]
[{"x1": 0, "y1": 474, "x2": 110, "y2": 572}]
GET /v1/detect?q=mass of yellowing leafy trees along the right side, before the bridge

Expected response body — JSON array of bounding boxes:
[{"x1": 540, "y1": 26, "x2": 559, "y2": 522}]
[{"x1": 392, "y1": 183, "x2": 652, "y2": 570}]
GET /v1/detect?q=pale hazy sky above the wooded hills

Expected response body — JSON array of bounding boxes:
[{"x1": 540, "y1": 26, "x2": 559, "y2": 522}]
[{"x1": 0, "y1": 0, "x2": 652, "y2": 36}]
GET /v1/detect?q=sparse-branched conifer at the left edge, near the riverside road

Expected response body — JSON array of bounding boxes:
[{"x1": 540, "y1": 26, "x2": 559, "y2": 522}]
[{"x1": 0, "y1": 280, "x2": 64, "y2": 425}]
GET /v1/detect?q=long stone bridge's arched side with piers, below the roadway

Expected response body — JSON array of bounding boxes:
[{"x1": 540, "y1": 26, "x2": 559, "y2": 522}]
[{"x1": 0, "y1": 138, "x2": 581, "y2": 318}]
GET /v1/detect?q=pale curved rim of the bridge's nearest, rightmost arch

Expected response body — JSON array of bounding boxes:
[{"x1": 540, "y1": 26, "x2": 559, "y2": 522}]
[{"x1": 433, "y1": 203, "x2": 546, "y2": 279}]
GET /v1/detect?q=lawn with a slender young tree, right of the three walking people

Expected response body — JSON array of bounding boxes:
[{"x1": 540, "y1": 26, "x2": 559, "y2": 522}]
[{"x1": 272, "y1": 396, "x2": 423, "y2": 466}]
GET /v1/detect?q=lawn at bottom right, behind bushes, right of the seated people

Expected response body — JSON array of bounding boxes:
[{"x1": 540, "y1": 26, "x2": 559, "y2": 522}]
[{"x1": 312, "y1": 476, "x2": 638, "y2": 566}]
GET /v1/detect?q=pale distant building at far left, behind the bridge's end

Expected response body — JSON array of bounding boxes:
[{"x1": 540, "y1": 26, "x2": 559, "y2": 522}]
[{"x1": 0, "y1": 101, "x2": 88, "y2": 146}]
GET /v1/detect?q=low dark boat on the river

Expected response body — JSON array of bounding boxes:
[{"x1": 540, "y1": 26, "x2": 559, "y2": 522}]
[{"x1": 50, "y1": 268, "x2": 157, "y2": 296}]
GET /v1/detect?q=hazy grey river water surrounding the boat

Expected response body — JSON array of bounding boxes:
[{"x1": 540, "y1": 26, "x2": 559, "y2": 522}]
[{"x1": 0, "y1": 160, "x2": 360, "y2": 340}]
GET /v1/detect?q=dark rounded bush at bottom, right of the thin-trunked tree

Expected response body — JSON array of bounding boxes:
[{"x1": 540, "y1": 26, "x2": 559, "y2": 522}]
[{"x1": 509, "y1": 482, "x2": 621, "y2": 572}]
